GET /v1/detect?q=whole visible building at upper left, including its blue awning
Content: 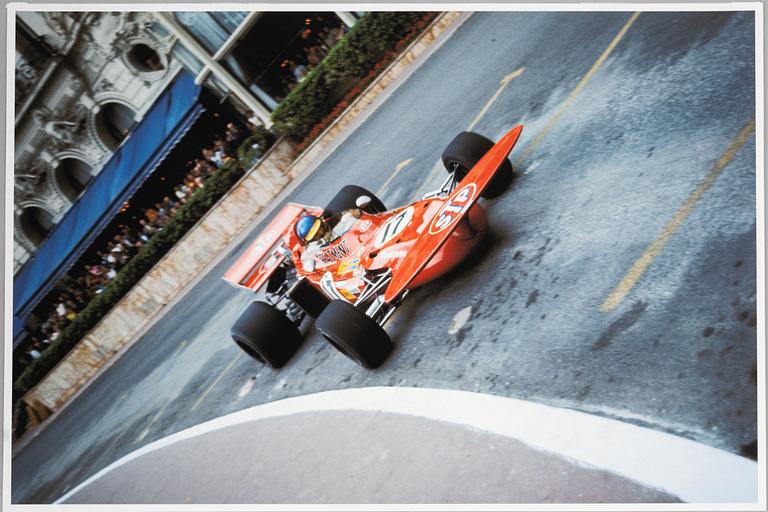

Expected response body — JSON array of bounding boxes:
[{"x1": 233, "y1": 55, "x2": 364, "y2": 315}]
[{"x1": 13, "y1": 11, "x2": 357, "y2": 350}]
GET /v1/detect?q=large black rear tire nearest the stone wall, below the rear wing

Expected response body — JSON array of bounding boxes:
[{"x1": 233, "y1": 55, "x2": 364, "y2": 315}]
[{"x1": 230, "y1": 301, "x2": 303, "y2": 368}]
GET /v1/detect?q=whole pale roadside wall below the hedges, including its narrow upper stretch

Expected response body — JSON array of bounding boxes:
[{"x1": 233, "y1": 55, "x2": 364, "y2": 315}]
[{"x1": 23, "y1": 12, "x2": 469, "y2": 411}]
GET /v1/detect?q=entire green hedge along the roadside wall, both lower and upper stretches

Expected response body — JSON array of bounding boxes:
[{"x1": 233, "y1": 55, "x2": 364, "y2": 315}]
[{"x1": 13, "y1": 12, "x2": 437, "y2": 400}]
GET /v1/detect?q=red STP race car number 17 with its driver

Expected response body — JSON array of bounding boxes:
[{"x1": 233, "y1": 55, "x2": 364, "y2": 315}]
[{"x1": 224, "y1": 126, "x2": 523, "y2": 368}]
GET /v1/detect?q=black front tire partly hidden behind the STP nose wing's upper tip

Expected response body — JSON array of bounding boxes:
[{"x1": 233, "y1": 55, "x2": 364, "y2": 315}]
[{"x1": 442, "y1": 132, "x2": 514, "y2": 199}]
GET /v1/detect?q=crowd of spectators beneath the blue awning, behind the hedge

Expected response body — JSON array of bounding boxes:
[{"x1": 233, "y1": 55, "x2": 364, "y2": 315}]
[{"x1": 19, "y1": 122, "x2": 256, "y2": 369}]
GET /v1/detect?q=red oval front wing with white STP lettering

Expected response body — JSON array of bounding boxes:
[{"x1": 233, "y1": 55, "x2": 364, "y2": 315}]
[{"x1": 384, "y1": 125, "x2": 523, "y2": 302}]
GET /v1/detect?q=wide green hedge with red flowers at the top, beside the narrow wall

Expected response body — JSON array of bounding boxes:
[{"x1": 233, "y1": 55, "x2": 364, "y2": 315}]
[{"x1": 272, "y1": 12, "x2": 437, "y2": 141}]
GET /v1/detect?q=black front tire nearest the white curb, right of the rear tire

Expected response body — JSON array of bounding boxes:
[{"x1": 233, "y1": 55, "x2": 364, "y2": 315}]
[{"x1": 315, "y1": 300, "x2": 393, "y2": 369}]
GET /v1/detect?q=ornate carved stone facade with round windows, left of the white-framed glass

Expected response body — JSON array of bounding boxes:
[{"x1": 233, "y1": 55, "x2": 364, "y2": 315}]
[{"x1": 13, "y1": 12, "x2": 180, "y2": 271}]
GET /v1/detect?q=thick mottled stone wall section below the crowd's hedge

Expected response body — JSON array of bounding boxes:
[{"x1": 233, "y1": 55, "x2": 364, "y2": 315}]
[{"x1": 24, "y1": 140, "x2": 297, "y2": 411}]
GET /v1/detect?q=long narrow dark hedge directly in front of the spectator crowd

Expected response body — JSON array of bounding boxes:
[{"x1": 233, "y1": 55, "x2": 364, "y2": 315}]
[{"x1": 13, "y1": 156, "x2": 250, "y2": 400}]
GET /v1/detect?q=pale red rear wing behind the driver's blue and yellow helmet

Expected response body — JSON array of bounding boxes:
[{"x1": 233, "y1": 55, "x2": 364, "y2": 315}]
[{"x1": 224, "y1": 203, "x2": 309, "y2": 291}]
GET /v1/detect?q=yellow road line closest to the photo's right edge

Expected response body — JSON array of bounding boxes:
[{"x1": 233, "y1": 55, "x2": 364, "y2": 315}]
[{"x1": 600, "y1": 118, "x2": 755, "y2": 313}]
